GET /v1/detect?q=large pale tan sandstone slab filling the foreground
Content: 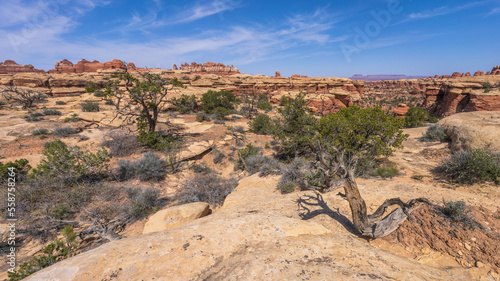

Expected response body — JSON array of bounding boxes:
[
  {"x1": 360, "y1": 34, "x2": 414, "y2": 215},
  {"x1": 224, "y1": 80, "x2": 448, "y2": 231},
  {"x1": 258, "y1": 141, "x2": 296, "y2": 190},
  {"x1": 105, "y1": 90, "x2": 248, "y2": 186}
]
[{"x1": 26, "y1": 175, "x2": 487, "y2": 281}]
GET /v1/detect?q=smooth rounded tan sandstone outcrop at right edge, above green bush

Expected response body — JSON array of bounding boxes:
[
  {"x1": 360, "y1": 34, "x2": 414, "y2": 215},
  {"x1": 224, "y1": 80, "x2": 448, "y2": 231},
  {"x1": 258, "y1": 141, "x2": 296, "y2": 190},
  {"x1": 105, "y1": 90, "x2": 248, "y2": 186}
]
[{"x1": 438, "y1": 111, "x2": 500, "y2": 152}]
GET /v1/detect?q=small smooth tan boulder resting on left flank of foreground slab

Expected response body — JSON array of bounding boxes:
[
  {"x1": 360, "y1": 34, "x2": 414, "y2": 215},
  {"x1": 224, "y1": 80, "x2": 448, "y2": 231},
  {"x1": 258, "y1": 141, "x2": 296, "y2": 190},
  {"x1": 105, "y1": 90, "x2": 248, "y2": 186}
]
[{"x1": 142, "y1": 202, "x2": 210, "y2": 234}]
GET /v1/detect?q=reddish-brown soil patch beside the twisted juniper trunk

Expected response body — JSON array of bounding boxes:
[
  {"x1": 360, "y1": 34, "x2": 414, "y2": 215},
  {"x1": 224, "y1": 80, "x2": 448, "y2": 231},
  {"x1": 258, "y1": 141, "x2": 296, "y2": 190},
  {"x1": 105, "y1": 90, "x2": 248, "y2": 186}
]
[{"x1": 384, "y1": 203, "x2": 500, "y2": 273}]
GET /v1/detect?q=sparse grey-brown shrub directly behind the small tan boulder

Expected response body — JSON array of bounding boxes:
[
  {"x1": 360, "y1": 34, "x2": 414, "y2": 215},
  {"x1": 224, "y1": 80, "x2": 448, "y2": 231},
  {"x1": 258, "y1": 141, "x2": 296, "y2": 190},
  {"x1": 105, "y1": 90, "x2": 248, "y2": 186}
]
[{"x1": 176, "y1": 173, "x2": 238, "y2": 206}]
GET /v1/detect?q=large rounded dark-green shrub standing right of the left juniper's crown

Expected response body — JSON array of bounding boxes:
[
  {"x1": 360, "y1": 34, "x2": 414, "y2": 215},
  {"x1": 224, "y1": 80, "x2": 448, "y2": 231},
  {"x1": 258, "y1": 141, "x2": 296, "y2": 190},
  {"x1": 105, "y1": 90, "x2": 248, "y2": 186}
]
[{"x1": 201, "y1": 90, "x2": 237, "y2": 119}]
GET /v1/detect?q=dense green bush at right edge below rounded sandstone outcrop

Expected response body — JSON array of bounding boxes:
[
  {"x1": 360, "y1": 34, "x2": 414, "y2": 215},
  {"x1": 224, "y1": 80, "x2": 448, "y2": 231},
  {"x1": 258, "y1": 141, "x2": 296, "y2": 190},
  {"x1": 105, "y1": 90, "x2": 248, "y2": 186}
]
[{"x1": 437, "y1": 147, "x2": 500, "y2": 184}]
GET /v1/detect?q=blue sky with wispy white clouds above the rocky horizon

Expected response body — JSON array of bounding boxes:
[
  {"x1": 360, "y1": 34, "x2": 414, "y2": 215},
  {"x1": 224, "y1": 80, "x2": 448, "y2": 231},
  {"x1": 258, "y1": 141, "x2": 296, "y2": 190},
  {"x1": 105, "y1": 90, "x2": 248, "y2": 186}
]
[{"x1": 0, "y1": 0, "x2": 500, "y2": 77}]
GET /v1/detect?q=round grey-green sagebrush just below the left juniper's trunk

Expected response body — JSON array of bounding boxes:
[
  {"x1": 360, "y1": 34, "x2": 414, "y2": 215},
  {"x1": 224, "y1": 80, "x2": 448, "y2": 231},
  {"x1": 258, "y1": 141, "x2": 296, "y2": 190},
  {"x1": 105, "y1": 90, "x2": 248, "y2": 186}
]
[{"x1": 135, "y1": 152, "x2": 167, "y2": 181}]
